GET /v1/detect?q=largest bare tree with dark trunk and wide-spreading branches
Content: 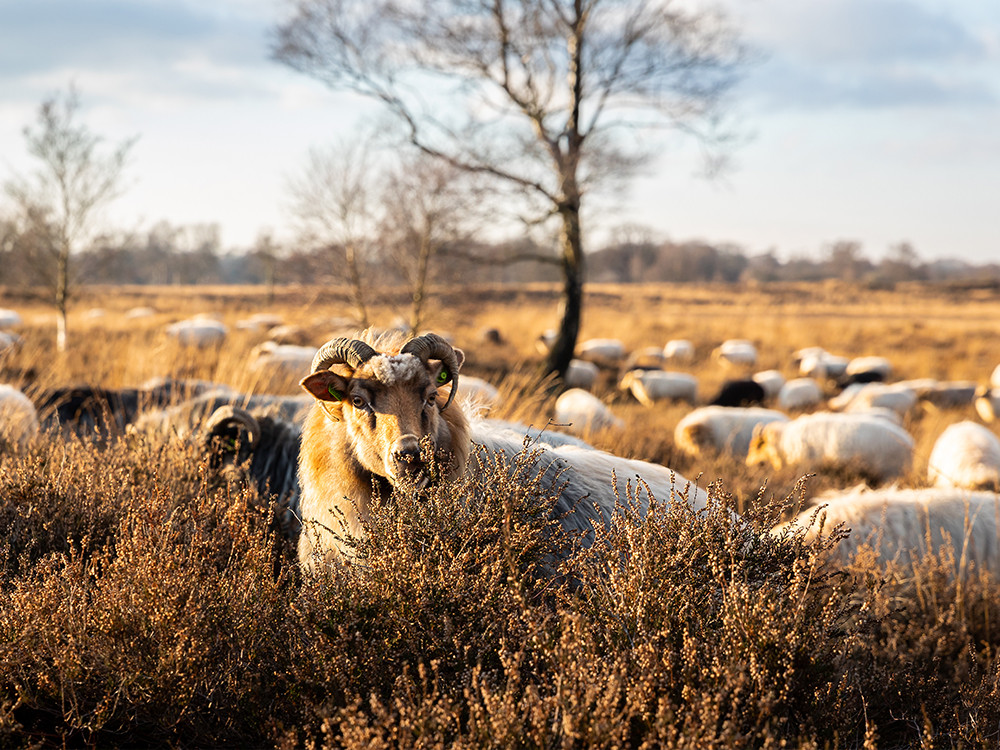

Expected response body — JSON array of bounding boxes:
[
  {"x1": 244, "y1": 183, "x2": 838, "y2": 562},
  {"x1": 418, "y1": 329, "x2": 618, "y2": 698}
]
[{"x1": 274, "y1": 0, "x2": 744, "y2": 374}]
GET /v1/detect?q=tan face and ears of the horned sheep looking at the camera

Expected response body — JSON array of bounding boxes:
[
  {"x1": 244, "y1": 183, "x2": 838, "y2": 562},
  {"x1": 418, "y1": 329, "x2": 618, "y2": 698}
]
[{"x1": 302, "y1": 350, "x2": 464, "y2": 489}]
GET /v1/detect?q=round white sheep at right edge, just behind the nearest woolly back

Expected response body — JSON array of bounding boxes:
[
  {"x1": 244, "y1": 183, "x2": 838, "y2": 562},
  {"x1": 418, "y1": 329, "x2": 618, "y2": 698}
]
[{"x1": 927, "y1": 422, "x2": 1000, "y2": 490}]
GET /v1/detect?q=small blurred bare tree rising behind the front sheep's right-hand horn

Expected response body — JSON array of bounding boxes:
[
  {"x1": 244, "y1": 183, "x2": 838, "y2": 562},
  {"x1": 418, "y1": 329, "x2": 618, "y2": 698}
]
[{"x1": 382, "y1": 153, "x2": 477, "y2": 334}]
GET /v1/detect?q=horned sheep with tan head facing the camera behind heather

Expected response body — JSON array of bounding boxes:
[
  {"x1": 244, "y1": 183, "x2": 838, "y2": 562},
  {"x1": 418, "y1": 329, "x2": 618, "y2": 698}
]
[{"x1": 299, "y1": 333, "x2": 707, "y2": 568}]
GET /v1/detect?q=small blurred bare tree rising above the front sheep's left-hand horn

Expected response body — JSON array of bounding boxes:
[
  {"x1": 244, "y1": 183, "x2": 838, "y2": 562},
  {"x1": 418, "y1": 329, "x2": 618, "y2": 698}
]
[{"x1": 288, "y1": 140, "x2": 378, "y2": 328}]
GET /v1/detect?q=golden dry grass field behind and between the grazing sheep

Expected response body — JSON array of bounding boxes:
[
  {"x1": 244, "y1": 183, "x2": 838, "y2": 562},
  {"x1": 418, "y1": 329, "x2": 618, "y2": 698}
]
[{"x1": 7, "y1": 282, "x2": 1000, "y2": 508}]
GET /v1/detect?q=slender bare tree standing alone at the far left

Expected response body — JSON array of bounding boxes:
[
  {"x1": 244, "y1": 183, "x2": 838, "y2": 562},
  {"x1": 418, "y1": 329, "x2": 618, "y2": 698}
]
[{"x1": 5, "y1": 87, "x2": 135, "y2": 351}]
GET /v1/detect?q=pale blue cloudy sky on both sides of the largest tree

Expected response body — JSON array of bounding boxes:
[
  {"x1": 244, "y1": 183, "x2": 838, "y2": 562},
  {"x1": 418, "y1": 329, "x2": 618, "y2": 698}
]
[{"x1": 0, "y1": 0, "x2": 1000, "y2": 263}]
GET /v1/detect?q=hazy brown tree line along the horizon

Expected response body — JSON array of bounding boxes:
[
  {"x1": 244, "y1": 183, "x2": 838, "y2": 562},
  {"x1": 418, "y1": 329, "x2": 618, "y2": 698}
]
[{"x1": 0, "y1": 221, "x2": 1000, "y2": 288}]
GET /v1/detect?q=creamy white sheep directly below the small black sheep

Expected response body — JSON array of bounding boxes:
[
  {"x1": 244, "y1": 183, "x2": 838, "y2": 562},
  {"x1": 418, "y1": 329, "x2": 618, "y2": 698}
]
[{"x1": 674, "y1": 406, "x2": 788, "y2": 459}]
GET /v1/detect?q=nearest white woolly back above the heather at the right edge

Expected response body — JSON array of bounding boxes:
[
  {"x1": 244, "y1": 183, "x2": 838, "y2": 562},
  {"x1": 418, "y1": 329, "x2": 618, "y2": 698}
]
[{"x1": 771, "y1": 487, "x2": 1000, "y2": 575}]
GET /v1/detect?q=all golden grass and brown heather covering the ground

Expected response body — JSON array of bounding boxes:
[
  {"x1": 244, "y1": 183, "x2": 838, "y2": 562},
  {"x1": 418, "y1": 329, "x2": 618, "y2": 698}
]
[{"x1": 0, "y1": 285, "x2": 1000, "y2": 748}]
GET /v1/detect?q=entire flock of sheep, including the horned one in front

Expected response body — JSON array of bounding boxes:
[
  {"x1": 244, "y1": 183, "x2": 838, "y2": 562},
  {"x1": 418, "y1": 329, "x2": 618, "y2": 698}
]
[{"x1": 0, "y1": 310, "x2": 1000, "y2": 573}]
